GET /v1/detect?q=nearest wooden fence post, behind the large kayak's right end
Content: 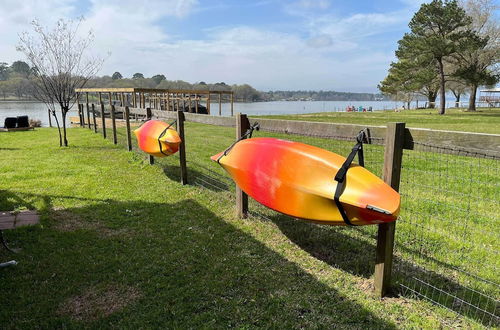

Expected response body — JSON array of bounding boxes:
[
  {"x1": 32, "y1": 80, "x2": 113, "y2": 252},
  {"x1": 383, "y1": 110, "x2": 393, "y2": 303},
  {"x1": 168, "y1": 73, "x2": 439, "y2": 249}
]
[{"x1": 374, "y1": 123, "x2": 405, "y2": 297}]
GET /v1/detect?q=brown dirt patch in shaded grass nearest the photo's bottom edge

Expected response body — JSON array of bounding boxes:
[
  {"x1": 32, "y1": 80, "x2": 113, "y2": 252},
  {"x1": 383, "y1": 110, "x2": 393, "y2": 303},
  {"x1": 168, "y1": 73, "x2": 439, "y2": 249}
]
[{"x1": 58, "y1": 286, "x2": 141, "y2": 321}]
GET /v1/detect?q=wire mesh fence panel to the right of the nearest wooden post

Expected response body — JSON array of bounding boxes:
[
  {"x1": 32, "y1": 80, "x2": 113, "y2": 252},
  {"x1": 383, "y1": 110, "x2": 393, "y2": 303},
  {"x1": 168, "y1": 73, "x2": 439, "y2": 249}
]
[{"x1": 395, "y1": 142, "x2": 500, "y2": 327}]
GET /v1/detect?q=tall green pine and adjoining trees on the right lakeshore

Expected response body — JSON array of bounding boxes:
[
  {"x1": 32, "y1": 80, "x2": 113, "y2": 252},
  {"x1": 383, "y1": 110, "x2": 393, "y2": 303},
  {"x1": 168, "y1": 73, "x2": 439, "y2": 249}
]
[{"x1": 378, "y1": 0, "x2": 500, "y2": 114}]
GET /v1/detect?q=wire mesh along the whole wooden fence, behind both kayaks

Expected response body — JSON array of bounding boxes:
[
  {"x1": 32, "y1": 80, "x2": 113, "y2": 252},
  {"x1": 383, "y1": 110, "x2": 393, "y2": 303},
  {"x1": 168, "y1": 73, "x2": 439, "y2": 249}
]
[{"x1": 88, "y1": 117, "x2": 500, "y2": 327}]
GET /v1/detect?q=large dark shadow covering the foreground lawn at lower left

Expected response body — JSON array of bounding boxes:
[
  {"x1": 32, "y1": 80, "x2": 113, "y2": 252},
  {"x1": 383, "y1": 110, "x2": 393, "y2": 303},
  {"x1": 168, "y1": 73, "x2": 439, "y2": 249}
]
[{"x1": 0, "y1": 191, "x2": 395, "y2": 328}]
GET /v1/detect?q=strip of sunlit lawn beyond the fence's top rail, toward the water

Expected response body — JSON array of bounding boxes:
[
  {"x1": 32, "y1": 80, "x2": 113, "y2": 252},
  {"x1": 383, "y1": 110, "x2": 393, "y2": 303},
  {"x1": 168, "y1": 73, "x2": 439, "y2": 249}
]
[{"x1": 260, "y1": 108, "x2": 500, "y2": 134}]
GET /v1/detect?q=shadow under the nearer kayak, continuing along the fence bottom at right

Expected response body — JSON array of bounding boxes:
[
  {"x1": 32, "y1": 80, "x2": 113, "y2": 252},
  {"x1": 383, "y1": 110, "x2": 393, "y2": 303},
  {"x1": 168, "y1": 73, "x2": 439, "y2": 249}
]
[{"x1": 267, "y1": 214, "x2": 499, "y2": 326}]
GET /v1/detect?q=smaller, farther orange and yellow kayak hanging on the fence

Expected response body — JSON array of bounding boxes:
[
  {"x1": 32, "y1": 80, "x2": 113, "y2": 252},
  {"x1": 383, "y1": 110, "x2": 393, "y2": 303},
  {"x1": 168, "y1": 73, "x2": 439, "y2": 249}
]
[{"x1": 134, "y1": 120, "x2": 181, "y2": 157}]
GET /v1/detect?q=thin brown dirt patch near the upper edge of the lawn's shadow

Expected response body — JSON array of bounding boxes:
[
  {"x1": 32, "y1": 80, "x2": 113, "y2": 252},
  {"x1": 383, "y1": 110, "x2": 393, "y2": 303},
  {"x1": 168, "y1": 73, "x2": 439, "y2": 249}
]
[{"x1": 50, "y1": 209, "x2": 131, "y2": 238}]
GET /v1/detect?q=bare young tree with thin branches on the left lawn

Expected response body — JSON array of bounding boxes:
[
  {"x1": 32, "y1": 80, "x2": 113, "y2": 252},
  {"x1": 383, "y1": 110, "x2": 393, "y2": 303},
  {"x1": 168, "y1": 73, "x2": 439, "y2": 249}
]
[{"x1": 17, "y1": 18, "x2": 104, "y2": 146}]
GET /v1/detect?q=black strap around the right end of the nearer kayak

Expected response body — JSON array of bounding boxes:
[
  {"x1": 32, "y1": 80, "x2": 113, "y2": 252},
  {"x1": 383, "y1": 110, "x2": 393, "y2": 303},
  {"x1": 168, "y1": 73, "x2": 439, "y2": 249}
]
[{"x1": 334, "y1": 128, "x2": 368, "y2": 226}]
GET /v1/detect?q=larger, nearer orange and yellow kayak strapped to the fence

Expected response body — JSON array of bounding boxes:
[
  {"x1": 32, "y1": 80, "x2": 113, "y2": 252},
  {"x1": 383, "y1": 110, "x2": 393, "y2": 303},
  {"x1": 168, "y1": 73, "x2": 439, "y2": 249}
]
[{"x1": 211, "y1": 138, "x2": 400, "y2": 225}]
